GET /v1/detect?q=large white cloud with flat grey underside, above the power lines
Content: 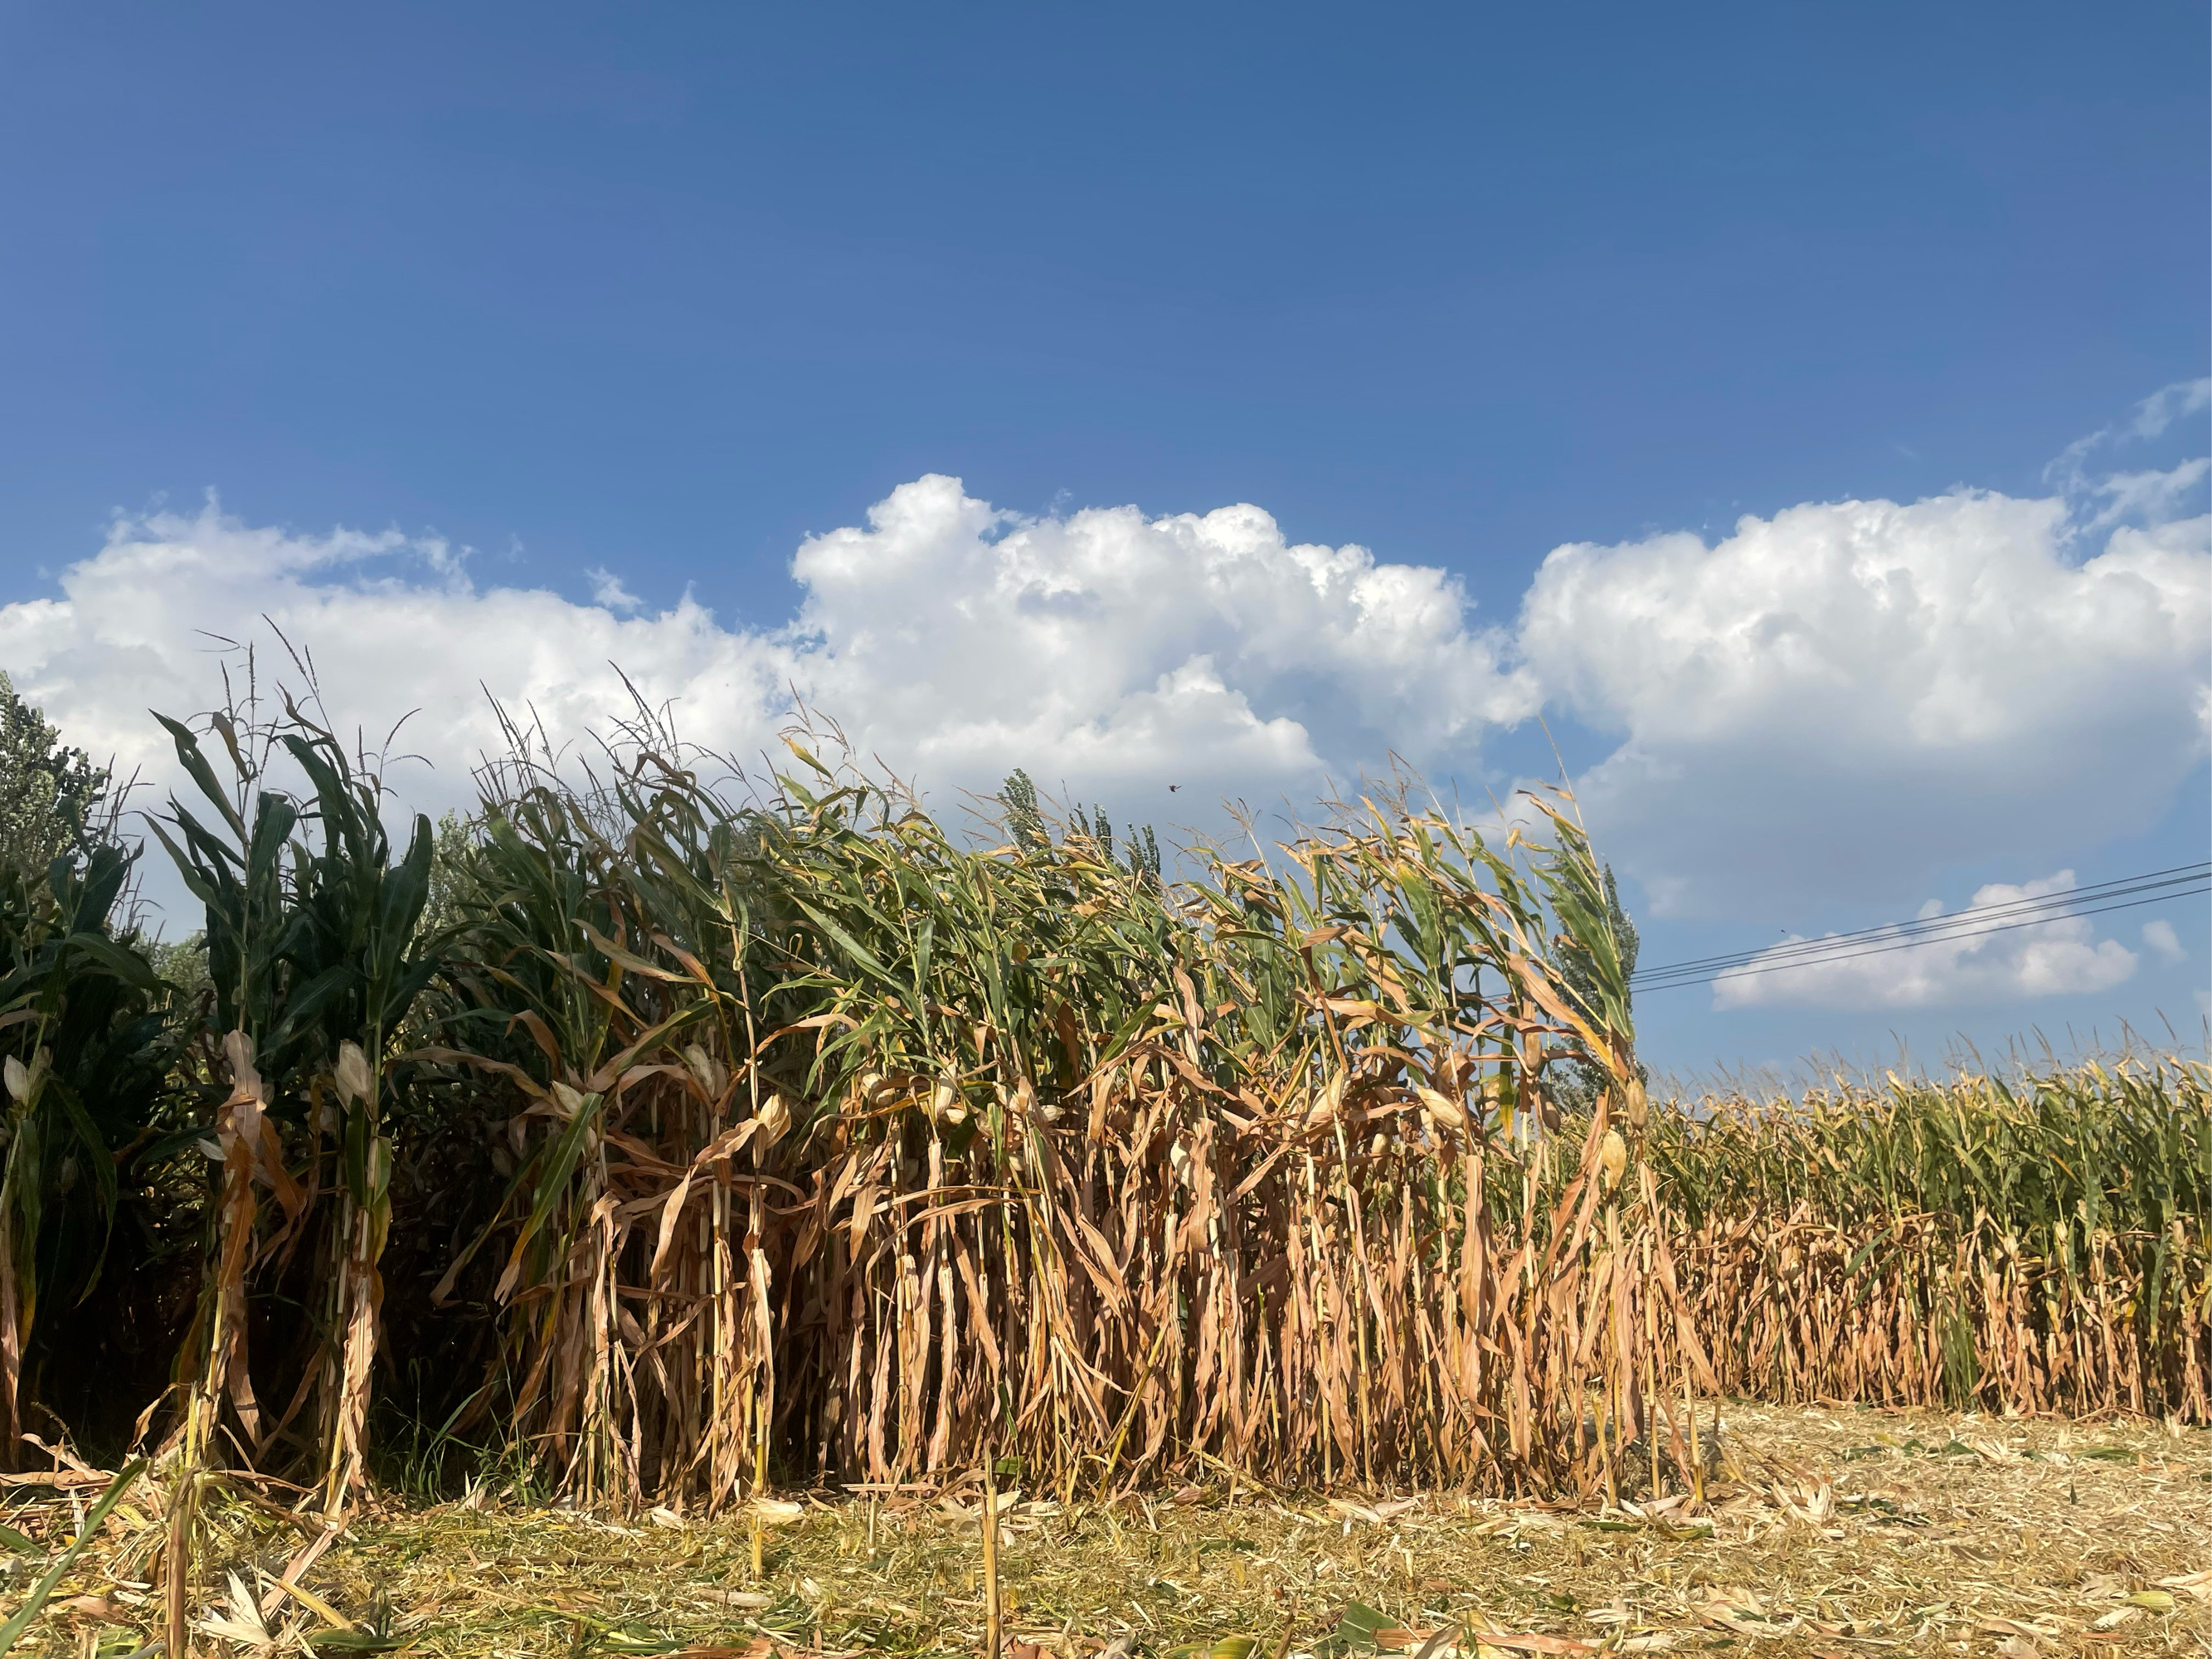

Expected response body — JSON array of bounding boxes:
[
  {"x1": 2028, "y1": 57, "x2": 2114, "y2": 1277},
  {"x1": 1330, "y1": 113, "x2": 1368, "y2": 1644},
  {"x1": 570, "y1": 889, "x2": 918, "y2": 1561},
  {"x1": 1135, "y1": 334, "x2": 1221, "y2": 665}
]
[{"x1": 1519, "y1": 491, "x2": 2212, "y2": 913}]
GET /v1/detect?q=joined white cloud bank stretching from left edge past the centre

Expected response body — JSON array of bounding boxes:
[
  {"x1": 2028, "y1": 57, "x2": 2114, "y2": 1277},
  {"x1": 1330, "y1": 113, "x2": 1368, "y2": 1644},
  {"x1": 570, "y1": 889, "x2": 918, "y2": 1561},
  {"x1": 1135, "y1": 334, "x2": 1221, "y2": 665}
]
[{"x1": 0, "y1": 475, "x2": 1535, "y2": 844}]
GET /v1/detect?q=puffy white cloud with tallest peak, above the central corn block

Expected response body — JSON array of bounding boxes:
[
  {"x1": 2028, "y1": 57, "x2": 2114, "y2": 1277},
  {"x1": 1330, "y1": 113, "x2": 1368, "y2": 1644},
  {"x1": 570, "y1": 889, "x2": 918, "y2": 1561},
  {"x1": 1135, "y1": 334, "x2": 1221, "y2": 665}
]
[{"x1": 787, "y1": 478, "x2": 1535, "y2": 792}]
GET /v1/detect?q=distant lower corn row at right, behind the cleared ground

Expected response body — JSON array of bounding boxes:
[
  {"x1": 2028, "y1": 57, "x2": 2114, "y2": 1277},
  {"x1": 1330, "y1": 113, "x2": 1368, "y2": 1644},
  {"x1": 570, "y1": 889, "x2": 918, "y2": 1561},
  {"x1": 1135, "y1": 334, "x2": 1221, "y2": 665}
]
[{"x1": 1646, "y1": 1059, "x2": 2212, "y2": 1423}]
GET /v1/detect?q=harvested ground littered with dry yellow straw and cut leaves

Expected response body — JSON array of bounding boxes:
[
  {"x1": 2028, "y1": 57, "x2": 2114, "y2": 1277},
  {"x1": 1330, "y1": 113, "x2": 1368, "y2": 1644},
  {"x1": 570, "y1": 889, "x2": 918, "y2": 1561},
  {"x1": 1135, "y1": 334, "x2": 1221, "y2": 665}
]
[{"x1": 0, "y1": 1404, "x2": 2212, "y2": 1659}]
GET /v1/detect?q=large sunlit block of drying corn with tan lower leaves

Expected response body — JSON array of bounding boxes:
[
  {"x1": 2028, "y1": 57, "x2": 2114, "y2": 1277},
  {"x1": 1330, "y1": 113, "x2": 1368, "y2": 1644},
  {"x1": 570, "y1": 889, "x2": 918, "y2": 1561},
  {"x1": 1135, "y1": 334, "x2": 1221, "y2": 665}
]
[{"x1": 426, "y1": 734, "x2": 1655, "y2": 1502}]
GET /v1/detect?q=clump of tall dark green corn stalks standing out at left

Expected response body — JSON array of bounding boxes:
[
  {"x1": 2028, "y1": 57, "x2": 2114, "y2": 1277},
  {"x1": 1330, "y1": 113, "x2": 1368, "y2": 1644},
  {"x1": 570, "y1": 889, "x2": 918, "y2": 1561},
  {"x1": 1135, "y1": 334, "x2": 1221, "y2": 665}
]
[{"x1": 153, "y1": 699, "x2": 434, "y2": 1643}]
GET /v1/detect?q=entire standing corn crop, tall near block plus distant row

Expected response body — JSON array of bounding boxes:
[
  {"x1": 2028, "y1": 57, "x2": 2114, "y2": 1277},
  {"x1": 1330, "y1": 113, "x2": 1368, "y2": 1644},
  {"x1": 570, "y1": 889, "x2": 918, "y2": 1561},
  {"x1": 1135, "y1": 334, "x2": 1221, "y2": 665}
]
[{"x1": 0, "y1": 684, "x2": 2212, "y2": 1652}]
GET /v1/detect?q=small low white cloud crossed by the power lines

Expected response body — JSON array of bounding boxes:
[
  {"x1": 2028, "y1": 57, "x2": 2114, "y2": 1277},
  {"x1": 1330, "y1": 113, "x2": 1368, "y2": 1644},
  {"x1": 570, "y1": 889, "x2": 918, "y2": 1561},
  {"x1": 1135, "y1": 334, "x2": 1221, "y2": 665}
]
[{"x1": 1712, "y1": 884, "x2": 2141, "y2": 1009}]
